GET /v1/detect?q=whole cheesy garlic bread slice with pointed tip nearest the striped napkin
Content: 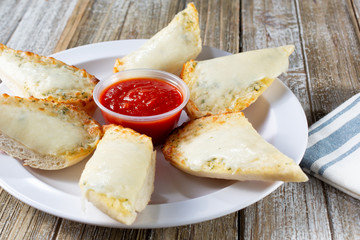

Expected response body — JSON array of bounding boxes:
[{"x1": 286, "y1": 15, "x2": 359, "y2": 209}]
[{"x1": 162, "y1": 112, "x2": 308, "y2": 182}]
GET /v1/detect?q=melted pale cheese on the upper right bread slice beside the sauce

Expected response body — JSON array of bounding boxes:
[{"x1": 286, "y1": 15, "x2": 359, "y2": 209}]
[{"x1": 191, "y1": 46, "x2": 293, "y2": 109}]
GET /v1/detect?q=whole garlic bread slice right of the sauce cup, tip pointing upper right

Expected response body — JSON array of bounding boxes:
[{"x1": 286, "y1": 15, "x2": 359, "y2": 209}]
[{"x1": 181, "y1": 45, "x2": 294, "y2": 119}]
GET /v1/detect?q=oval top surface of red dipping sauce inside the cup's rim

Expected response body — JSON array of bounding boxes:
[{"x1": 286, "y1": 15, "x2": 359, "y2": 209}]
[{"x1": 100, "y1": 78, "x2": 183, "y2": 116}]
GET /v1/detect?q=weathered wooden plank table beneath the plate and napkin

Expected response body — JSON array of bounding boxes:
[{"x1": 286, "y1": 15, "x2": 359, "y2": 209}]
[{"x1": 0, "y1": 0, "x2": 360, "y2": 239}]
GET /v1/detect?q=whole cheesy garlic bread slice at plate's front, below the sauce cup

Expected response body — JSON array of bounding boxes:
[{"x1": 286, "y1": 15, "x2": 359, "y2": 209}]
[{"x1": 79, "y1": 125, "x2": 155, "y2": 225}]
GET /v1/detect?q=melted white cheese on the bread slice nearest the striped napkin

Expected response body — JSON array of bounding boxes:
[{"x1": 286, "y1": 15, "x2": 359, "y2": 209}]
[{"x1": 181, "y1": 118, "x2": 275, "y2": 172}]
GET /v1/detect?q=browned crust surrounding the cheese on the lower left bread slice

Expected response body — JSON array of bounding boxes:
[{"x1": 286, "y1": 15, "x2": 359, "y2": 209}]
[{"x1": 0, "y1": 94, "x2": 102, "y2": 170}]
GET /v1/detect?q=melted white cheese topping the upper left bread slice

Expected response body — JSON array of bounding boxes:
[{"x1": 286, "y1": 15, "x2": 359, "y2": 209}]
[{"x1": 0, "y1": 51, "x2": 92, "y2": 98}]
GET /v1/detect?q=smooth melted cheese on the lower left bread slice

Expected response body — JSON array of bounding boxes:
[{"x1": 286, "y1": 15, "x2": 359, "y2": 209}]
[{"x1": 0, "y1": 105, "x2": 88, "y2": 154}]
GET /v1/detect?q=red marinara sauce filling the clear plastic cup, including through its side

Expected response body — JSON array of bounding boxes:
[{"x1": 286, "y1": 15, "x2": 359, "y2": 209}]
[{"x1": 99, "y1": 78, "x2": 184, "y2": 145}]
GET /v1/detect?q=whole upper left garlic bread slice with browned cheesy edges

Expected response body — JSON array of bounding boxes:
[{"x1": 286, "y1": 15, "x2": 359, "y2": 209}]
[{"x1": 0, "y1": 43, "x2": 99, "y2": 114}]
